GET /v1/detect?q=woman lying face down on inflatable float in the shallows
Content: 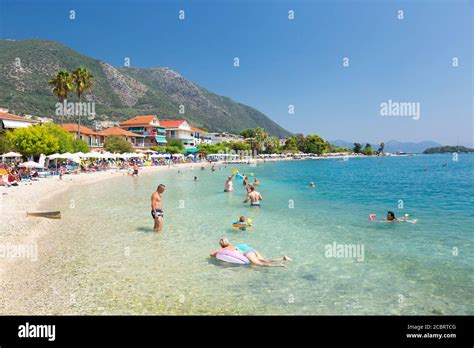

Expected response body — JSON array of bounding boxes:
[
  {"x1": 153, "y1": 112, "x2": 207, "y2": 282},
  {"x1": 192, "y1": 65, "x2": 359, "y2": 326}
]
[{"x1": 211, "y1": 238, "x2": 292, "y2": 268}]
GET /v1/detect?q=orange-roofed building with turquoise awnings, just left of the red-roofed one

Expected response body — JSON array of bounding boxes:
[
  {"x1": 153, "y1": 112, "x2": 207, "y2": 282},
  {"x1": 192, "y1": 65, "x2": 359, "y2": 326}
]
[{"x1": 119, "y1": 115, "x2": 167, "y2": 147}]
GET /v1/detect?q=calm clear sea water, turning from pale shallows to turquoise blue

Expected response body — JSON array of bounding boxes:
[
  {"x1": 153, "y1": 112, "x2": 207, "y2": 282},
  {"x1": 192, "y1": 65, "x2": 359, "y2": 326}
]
[{"x1": 35, "y1": 155, "x2": 474, "y2": 315}]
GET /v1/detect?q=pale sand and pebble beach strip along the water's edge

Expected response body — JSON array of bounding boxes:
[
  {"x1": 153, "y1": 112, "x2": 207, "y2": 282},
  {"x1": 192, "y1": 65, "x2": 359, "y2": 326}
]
[{"x1": 0, "y1": 163, "x2": 204, "y2": 314}]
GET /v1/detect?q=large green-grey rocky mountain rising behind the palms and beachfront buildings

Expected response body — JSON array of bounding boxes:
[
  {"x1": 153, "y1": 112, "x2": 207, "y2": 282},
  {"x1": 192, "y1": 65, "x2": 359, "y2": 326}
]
[{"x1": 0, "y1": 40, "x2": 291, "y2": 138}]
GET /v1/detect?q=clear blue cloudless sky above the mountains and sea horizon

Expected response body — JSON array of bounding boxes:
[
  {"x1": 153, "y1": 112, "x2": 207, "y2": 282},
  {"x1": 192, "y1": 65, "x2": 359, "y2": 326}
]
[{"x1": 0, "y1": 0, "x2": 474, "y2": 146}]
